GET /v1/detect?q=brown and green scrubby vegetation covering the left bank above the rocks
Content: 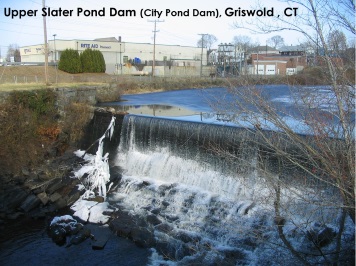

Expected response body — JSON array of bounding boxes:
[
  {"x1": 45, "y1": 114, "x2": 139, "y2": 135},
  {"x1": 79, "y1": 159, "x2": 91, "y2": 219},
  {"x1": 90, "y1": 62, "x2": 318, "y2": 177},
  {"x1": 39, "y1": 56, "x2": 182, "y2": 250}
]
[{"x1": 0, "y1": 89, "x2": 93, "y2": 176}]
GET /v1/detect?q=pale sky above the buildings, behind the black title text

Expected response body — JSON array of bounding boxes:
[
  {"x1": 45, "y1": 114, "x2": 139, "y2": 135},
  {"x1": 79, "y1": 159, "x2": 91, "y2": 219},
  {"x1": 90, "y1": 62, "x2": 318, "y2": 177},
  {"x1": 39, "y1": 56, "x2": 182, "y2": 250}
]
[{"x1": 0, "y1": 0, "x2": 320, "y2": 56}]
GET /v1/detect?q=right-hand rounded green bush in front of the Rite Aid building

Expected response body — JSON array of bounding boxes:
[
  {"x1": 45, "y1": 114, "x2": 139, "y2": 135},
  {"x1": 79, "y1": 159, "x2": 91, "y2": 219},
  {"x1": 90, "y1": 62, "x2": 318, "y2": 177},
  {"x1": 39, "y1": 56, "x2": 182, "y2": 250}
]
[{"x1": 80, "y1": 49, "x2": 106, "y2": 73}]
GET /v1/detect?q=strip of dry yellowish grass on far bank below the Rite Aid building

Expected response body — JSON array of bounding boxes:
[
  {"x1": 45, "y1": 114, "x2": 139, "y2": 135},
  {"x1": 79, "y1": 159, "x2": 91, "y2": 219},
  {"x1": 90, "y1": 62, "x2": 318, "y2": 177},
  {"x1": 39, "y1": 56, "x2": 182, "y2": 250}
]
[{"x1": 0, "y1": 66, "x2": 226, "y2": 95}]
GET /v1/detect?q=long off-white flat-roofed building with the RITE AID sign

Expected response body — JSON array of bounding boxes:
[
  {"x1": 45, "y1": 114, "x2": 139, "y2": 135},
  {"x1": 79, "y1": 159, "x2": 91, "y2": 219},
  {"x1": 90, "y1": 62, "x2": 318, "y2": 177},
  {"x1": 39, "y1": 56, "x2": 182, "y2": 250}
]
[{"x1": 20, "y1": 37, "x2": 208, "y2": 76}]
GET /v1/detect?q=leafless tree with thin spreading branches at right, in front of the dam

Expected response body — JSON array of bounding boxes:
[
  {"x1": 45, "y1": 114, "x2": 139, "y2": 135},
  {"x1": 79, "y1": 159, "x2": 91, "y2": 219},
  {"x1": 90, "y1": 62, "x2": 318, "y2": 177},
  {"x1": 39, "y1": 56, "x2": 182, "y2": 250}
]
[{"x1": 210, "y1": 0, "x2": 355, "y2": 265}]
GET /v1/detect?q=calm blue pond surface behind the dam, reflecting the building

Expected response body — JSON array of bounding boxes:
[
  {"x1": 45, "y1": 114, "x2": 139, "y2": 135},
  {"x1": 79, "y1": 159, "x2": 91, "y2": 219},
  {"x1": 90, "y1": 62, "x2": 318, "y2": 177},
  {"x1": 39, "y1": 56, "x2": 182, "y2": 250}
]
[{"x1": 99, "y1": 85, "x2": 355, "y2": 134}]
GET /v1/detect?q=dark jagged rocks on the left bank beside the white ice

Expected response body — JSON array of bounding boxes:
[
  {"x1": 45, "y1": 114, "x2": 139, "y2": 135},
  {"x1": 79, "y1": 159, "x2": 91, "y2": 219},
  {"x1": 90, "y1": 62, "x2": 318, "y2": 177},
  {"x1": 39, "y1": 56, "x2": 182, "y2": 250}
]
[{"x1": 0, "y1": 151, "x2": 82, "y2": 226}]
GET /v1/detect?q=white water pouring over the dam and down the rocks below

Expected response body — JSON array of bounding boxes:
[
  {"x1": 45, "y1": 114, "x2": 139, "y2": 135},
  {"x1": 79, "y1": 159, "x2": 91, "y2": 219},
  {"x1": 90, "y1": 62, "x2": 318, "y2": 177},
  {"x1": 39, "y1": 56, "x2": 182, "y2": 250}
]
[{"x1": 109, "y1": 115, "x2": 354, "y2": 265}]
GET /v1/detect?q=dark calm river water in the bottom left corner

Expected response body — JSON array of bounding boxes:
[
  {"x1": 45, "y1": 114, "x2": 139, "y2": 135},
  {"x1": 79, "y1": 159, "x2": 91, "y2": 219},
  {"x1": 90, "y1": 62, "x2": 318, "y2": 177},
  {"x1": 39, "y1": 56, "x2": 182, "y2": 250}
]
[{"x1": 0, "y1": 215, "x2": 151, "y2": 266}]
